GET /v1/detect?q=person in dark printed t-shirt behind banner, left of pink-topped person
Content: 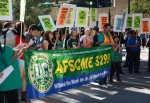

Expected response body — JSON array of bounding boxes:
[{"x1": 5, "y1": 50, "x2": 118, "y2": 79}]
[{"x1": 67, "y1": 30, "x2": 80, "y2": 49}]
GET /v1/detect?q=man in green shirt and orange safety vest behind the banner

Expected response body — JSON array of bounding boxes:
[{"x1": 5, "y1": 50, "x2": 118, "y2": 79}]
[{"x1": 98, "y1": 23, "x2": 114, "y2": 88}]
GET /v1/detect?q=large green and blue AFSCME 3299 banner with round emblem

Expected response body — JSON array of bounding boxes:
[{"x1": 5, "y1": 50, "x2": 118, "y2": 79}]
[{"x1": 25, "y1": 46, "x2": 111, "y2": 99}]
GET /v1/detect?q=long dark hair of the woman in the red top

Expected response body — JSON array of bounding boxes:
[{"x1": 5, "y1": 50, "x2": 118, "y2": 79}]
[{"x1": 15, "y1": 22, "x2": 25, "y2": 38}]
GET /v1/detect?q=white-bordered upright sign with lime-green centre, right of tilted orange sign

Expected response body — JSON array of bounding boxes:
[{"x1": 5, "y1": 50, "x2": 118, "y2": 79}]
[{"x1": 75, "y1": 7, "x2": 89, "y2": 27}]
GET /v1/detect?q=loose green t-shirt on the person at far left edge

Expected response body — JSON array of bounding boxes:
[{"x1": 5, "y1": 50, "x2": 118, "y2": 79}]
[{"x1": 0, "y1": 46, "x2": 22, "y2": 91}]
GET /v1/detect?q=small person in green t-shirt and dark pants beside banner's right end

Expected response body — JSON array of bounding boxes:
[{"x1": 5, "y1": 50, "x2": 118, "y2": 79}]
[{"x1": 110, "y1": 36, "x2": 122, "y2": 83}]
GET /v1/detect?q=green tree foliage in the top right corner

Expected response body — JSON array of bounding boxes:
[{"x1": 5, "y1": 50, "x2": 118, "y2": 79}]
[{"x1": 130, "y1": 0, "x2": 150, "y2": 17}]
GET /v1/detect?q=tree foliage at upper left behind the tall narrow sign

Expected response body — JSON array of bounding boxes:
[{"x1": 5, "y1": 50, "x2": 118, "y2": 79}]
[{"x1": 13, "y1": 0, "x2": 51, "y2": 27}]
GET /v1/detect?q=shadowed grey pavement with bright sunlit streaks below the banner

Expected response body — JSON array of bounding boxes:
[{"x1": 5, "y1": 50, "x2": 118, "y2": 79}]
[{"x1": 20, "y1": 49, "x2": 150, "y2": 103}]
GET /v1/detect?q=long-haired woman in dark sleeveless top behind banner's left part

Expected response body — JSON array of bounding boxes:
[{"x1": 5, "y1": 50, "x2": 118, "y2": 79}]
[{"x1": 42, "y1": 30, "x2": 55, "y2": 50}]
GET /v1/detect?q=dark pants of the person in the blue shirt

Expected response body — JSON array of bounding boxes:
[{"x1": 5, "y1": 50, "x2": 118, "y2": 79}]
[{"x1": 128, "y1": 50, "x2": 140, "y2": 73}]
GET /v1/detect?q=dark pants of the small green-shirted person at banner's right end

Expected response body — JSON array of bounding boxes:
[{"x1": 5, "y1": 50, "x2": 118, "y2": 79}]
[{"x1": 110, "y1": 62, "x2": 121, "y2": 81}]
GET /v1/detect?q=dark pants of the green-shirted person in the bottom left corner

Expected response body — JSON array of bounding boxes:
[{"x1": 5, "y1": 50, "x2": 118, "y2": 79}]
[{"x1": 0, "y1": 89, "x2": 19, "y2": 103}]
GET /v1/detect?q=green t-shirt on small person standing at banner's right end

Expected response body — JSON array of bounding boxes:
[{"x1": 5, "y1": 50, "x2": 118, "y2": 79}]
[{"x1": 111, "y1": 50, "x2": 122, "y2": 62}]
